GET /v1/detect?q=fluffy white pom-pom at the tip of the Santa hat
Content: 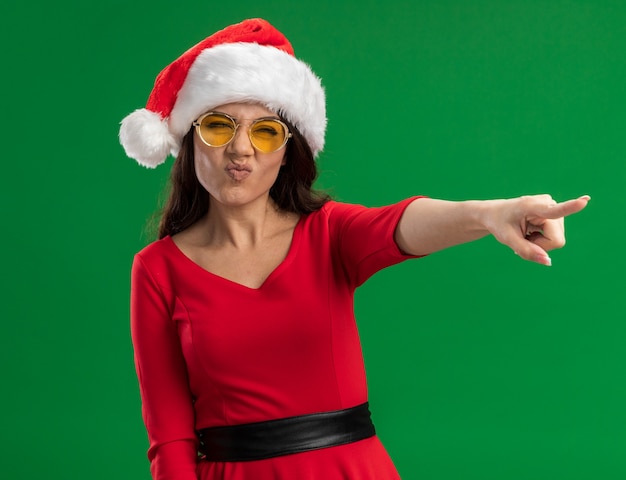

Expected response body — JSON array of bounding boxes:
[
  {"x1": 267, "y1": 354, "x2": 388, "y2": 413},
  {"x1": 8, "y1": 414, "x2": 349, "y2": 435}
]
[{"x1": 119, "y1": 108, "x2": 178, "y2": 168}]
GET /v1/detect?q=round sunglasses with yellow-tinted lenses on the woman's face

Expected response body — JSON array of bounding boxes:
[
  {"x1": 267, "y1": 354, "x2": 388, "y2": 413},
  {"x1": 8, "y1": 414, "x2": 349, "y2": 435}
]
[{"x1": 193, "y1": 112, "x2": 291, "y2": 153}]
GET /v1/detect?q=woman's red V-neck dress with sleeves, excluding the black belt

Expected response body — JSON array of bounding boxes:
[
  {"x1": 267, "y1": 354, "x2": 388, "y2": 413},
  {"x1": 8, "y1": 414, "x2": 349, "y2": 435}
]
[{"x1": 131, "y1": 199, "x2": 422, "y2": 480}]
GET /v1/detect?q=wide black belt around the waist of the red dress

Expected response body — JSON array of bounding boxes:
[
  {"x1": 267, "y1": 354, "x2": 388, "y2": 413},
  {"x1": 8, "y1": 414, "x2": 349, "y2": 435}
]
[{"x1": 198, "y1": 402, "x2": 376, "y2": 462}]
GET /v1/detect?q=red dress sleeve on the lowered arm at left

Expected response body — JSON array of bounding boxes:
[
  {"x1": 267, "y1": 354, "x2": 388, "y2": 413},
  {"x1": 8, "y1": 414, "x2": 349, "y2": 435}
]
[{"x1": 131, "y1": 255, "x2": 197, "y2": 480}]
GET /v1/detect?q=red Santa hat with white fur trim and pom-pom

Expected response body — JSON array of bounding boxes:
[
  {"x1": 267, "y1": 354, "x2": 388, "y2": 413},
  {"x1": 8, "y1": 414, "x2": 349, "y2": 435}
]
[{"x1": 119, "y1": 19, "x2": 326, "y2": 168}]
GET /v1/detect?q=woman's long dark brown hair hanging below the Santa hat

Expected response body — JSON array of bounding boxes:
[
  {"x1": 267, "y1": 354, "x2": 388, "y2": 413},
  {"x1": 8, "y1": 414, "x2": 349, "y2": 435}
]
[{"x1": 158, "y1": 120, "x2": 330, "y2": 238}]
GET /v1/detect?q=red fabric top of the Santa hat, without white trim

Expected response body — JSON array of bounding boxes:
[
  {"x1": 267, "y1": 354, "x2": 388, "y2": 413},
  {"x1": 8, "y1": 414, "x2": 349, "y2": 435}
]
[{"x1": 146, "y1": 18, "x2": 294, "y2": 118}]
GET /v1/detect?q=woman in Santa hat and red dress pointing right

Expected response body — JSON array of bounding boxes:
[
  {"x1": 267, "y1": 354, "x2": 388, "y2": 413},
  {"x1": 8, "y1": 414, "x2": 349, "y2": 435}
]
[{"x1": 120, "y1": 19, "x2": 589, "y2": 480}]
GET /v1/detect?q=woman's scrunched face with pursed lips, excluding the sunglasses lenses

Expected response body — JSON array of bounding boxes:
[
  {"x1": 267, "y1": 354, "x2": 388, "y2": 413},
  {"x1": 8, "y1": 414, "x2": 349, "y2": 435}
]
[{"x1": 194, "y1": 103, "x2": 286, "y2": 207}]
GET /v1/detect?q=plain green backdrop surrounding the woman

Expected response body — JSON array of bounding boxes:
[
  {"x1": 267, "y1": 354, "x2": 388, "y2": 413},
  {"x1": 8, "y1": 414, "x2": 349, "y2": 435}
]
[{"x1": 0, "y1": 0, "x2": 626, "y2": 480}]
